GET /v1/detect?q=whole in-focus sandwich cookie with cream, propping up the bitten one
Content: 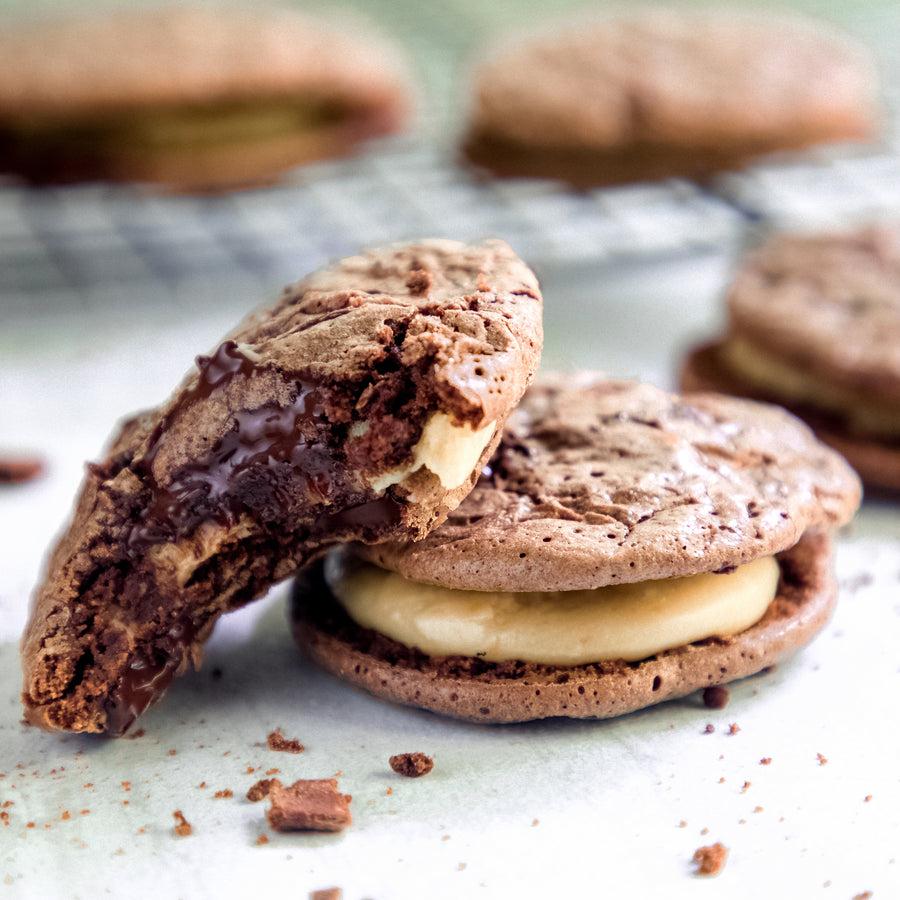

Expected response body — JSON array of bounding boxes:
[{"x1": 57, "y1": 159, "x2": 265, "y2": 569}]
[{"x1": 292, "y1": 376, "x2": 860, "y2": 722}]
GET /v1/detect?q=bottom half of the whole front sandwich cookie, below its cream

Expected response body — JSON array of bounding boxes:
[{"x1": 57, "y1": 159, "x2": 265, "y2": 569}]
[{"x1": 292, "y1": 532, "x2": 837, "y2": 723}]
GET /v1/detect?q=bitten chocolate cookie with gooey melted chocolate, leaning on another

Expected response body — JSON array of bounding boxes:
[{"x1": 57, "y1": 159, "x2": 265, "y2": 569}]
[{"x1": 22, "y1": 240, "x2": 541, "y2": 734}]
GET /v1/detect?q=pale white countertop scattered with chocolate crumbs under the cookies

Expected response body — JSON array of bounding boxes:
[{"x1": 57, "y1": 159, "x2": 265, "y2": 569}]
[{"x1": 0, "y1": 248, "x2": 900, "y2": 900}]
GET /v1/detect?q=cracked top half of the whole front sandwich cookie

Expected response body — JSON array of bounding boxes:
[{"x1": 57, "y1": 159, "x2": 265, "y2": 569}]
[{"x1": 360, "y1": 375, "x2": 860, "y2": 591}]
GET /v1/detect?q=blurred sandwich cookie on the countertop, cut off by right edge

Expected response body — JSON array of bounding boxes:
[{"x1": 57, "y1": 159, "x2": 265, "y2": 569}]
[{"x1": 681, "y1": 226, "x2": 900, "y2": 491}]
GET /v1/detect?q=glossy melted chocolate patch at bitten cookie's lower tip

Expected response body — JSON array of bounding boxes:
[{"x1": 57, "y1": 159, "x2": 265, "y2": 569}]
[{"x1": 106, "y1": 618, "x2": 196, "y2": 736}]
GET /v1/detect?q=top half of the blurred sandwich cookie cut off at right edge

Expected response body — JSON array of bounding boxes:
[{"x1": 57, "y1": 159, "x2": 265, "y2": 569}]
[{"x1": 728, "y1": 225, "x2": 900, "y2": 402}]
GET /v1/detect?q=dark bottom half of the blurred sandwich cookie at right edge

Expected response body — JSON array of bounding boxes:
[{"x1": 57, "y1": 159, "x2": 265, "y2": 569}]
[{"x1": 679, "y1": 343, "x2": 900, "y2": 493}]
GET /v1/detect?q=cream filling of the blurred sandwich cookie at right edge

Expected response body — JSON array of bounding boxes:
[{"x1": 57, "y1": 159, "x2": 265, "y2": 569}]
[{"x1": 721, "y1": 336, "x2": 900, "y2": 439}]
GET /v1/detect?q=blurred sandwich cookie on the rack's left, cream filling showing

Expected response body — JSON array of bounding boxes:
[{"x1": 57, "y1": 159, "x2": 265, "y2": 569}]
[{"x1": 0, "y1": 6, "x2": 409, "y2": 190}]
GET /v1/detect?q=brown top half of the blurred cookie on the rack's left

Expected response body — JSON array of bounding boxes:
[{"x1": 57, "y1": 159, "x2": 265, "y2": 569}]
[{"x1": 0, "y1": 5, "x2": 407, "y2": 121}]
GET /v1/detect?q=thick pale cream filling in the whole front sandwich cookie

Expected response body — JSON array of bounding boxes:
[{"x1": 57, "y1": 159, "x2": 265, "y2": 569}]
[{"x1": 325, "y1": 549, "x2": 780, "y2": 666}]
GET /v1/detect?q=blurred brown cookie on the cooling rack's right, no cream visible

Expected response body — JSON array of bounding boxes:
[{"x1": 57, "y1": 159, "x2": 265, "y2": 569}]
[{"x1": 464, "y1": 9, "x2": 876, "y2": 187}]
